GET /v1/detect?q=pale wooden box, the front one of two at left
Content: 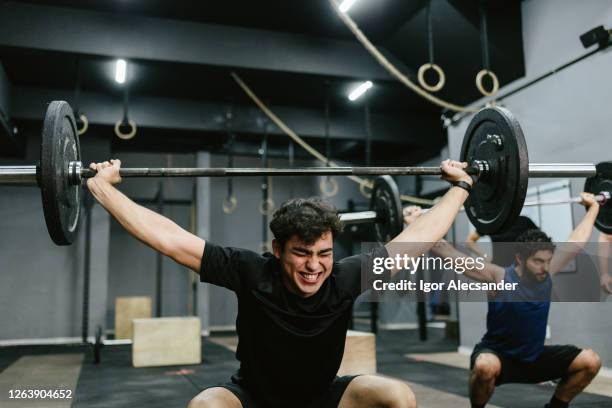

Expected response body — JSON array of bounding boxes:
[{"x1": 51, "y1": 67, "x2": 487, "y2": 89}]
[{"x1": 132, "y1": 317, "x2": 202, "y2": 367}]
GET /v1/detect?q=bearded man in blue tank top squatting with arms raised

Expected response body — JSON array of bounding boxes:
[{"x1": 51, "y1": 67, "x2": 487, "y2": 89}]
[{"x1": 432, "y1": 193, "x2": 601, "y2": 408}]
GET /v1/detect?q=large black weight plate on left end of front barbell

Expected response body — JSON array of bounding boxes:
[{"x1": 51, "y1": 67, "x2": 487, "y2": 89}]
[{"x1": 39, "y1": 101, "x2": 81, "y2": 245}]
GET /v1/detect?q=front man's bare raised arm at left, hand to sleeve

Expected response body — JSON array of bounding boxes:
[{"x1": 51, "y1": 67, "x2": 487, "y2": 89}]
[{"x1": 87, "y1": 160, "x2": 205, "y2": 273}]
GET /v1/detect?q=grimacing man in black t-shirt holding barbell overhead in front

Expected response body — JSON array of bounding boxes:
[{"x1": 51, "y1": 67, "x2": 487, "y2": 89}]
[{"x1": 87, "y1": 160, "x2": 473, "y2": 408}]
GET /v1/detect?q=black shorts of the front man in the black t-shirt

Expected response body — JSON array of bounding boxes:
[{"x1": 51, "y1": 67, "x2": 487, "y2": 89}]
[{"x1": 216, "y1": 375, "x2": 358, "y2": 408}]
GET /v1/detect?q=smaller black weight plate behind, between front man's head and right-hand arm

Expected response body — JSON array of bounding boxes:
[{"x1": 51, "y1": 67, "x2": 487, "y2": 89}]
[{"x1": 370, "y1": 176, "x2": 404, "y2": 243}]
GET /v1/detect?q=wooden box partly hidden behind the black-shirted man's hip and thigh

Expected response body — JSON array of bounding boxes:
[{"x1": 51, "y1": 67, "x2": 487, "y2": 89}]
[{"x1": 338, "y1": 330, "x2": 376, "y2": 376}]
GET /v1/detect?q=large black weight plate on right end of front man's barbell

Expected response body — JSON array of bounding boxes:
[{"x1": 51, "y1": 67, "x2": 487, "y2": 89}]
[{"x1": 461, "y1": 107, "x2": 529, "y2": 235}]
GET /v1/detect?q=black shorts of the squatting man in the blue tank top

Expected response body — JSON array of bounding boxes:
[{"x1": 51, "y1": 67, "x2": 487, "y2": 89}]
[{"x1": 470, "y1": 343, "x2": 582, "y2": 385}]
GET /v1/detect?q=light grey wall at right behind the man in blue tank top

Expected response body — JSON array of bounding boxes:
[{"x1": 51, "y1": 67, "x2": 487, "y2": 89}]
[{"x1": 448, "y1": 0, "x2": 612, "y2": 367}]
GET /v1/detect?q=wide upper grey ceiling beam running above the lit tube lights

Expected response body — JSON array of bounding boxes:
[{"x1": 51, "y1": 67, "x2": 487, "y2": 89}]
[{"x1": 0, "y1": 1, "x2": 409, "y2": 81}]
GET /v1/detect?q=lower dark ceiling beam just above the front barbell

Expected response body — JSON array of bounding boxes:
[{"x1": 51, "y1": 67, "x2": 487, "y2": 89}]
[{"x1": 11, "y1": 86, "x2": 444, "y2": 146}]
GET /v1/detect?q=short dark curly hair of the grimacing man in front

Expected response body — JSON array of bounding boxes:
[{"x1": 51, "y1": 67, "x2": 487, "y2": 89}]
[{"x1": 270, "y1": 197, "x2": 342, "y2": 250}]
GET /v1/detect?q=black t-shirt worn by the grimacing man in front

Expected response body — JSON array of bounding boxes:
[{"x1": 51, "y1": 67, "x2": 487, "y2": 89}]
[{"x1": 200, "y1": 242, "x2": 388, "y2": 407}]
